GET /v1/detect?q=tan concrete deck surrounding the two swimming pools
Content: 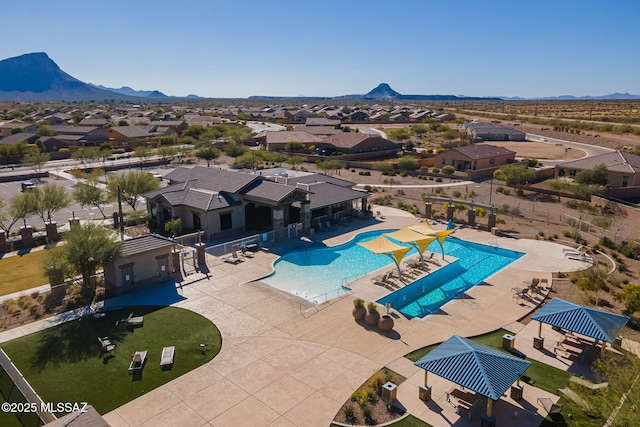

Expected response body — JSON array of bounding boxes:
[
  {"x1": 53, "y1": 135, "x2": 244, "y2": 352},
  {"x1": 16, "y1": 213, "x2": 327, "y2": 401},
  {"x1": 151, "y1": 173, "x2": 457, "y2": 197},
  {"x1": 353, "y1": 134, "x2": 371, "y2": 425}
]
[{"x1": 0, "y1": 207, "x2": 620, "y2": 427}]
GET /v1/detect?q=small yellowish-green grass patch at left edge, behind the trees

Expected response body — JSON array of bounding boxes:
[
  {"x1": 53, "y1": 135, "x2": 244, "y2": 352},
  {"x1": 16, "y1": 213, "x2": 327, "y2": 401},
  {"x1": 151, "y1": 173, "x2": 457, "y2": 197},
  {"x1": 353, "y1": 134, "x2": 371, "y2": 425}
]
[{"x1": 0, "y1": 251, "x2": 49, "y2": 295}]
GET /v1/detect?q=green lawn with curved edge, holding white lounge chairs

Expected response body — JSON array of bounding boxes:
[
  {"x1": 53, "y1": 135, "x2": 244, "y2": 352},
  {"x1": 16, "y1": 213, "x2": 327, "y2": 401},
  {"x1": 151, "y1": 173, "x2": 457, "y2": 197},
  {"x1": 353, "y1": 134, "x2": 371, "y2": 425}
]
[{"x1": 2, "y1": 307, "x2": 222, "y2": 414}]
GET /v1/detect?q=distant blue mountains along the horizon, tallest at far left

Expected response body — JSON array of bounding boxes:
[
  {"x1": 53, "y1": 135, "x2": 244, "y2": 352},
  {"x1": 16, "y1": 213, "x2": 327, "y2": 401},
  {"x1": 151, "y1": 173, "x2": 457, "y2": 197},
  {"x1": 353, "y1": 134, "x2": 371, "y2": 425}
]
[{"x1": 0, "y1": 52, "x2": 640, "y2": 102}]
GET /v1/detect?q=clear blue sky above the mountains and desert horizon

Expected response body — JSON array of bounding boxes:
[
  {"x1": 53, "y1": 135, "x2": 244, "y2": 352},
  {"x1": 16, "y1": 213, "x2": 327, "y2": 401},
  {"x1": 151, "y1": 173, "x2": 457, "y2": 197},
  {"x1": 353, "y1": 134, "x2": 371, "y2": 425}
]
[{"x1": 0, "y1": 0, "x2": 640, "y2": 98}]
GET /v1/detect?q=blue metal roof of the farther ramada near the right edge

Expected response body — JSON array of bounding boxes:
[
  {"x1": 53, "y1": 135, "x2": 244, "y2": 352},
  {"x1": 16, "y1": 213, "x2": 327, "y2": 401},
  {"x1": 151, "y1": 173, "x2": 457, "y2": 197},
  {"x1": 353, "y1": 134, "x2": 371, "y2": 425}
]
[{"x1": 531, "y1": 298, "x2": 629, "y2": 342}]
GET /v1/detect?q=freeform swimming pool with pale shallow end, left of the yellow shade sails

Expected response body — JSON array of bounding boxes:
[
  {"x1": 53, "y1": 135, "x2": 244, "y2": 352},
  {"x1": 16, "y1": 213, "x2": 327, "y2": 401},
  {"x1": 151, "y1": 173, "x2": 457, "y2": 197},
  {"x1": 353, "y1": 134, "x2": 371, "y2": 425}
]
[{"x1": 260, "y1": 230, "x2": 404, "y2": 303}]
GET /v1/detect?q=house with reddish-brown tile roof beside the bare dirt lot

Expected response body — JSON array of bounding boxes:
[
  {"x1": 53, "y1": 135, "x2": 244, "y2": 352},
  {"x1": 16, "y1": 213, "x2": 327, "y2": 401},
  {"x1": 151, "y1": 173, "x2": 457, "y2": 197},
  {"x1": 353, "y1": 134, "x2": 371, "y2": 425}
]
[{"x1": 434, "y1": 144, "x2": 516, "y2": 172}]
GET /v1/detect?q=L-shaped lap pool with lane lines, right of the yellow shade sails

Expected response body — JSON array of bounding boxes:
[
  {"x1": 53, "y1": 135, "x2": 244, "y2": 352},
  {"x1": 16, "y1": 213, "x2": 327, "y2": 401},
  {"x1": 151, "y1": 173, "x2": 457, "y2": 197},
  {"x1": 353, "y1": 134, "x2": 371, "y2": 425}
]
[{"x1": 377, "y1": 237, "x2": 524, "y2": 317}]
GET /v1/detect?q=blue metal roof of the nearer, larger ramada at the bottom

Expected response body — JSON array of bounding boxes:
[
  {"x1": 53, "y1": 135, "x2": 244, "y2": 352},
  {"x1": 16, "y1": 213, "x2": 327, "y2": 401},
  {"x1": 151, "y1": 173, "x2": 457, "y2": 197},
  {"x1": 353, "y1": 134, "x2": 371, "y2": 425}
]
[{"x1": 415, "y1": 335, "x2": 531, "y2": 400}]
